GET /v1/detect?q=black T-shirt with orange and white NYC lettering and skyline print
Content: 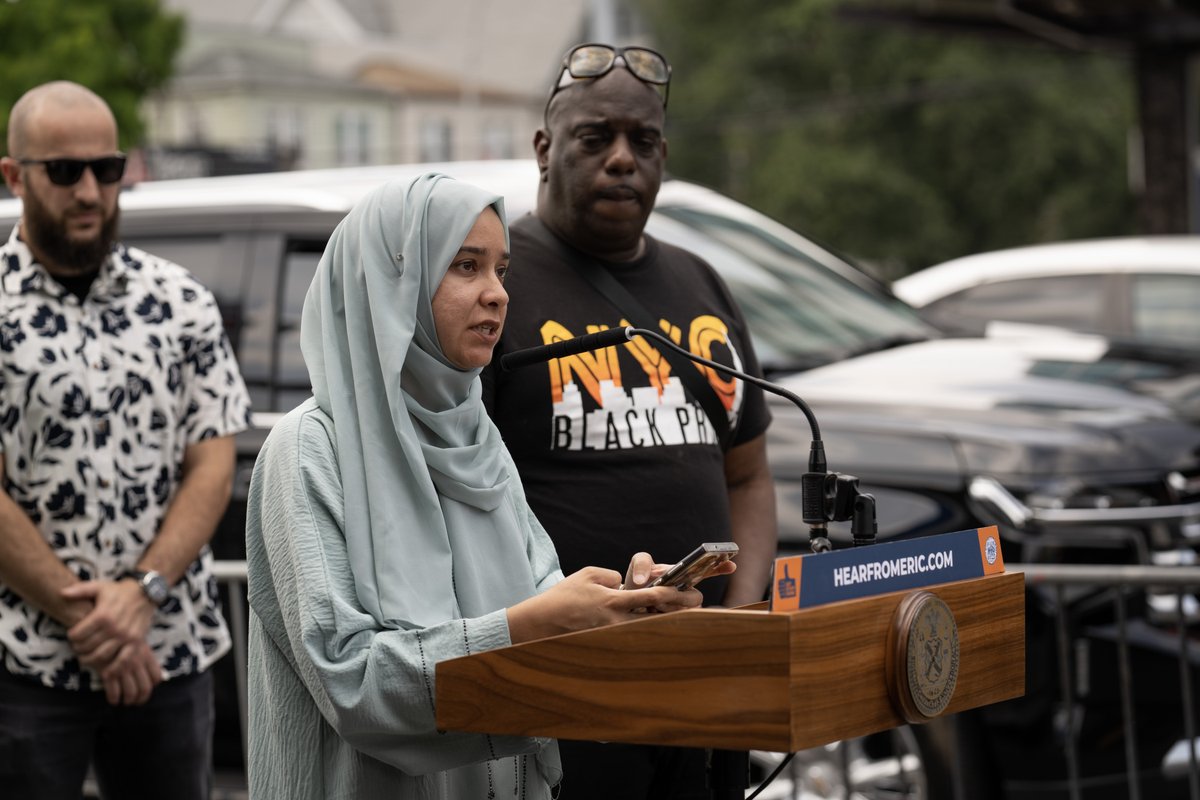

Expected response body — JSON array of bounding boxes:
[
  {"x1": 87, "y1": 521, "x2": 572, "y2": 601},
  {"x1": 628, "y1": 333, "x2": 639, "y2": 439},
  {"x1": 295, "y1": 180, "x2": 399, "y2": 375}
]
[{"x1": 482, "y1": 215, "x2": 770, "y2": 603}]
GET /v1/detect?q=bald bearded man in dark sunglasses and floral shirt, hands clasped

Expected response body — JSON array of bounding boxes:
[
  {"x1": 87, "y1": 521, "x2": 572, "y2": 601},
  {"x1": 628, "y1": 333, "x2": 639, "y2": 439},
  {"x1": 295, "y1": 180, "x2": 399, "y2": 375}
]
[{"x1": 0, "y1": 82, "x2": 250, "y2": 800}]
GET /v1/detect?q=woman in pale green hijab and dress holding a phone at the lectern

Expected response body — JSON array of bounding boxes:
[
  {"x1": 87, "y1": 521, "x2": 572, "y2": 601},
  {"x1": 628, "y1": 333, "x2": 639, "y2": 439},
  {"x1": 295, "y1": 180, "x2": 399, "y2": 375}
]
[{"x1": 246, "y1": 174, "x2": 701, "y2": 800}]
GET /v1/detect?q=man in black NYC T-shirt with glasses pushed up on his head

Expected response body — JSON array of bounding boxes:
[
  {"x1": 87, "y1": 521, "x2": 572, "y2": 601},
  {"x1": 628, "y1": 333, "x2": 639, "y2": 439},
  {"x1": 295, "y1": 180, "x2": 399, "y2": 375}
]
[{"x1": 484, "y1": 44, "x2": 776, "y2": 800}]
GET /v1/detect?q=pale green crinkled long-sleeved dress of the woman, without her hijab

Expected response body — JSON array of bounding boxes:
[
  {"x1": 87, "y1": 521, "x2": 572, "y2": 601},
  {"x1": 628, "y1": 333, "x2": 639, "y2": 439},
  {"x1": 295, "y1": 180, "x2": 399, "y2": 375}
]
[{"x1": 246, "y1": 401, "x2": 562, "y2": 800}]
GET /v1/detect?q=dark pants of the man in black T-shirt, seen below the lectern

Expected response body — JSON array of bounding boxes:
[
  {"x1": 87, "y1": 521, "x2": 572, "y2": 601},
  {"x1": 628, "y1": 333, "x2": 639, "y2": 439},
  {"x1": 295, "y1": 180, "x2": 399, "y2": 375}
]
[{"x1": 558, "y1": 739, "x2": 712, "y2": 800}]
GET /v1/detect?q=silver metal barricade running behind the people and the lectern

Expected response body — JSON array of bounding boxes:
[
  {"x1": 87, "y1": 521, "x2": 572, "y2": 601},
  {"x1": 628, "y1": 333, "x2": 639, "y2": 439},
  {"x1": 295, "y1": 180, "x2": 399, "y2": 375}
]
[{"x1": 206, "y1": 561, "x2": 1200, "y2": 800}]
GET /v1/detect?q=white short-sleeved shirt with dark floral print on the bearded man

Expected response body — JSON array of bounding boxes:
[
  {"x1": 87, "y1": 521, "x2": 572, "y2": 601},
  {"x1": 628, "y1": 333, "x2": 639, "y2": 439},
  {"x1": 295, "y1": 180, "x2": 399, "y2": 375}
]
[{"x1": 0, "y1": 229, "x2": 250, "y2": 690}]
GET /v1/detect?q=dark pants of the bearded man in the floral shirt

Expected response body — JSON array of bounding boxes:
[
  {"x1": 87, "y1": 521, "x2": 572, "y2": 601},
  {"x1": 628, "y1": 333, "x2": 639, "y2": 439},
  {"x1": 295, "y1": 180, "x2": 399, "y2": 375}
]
[{"x1": 0, "y1": 669, "x2": 214, "y2": 800}]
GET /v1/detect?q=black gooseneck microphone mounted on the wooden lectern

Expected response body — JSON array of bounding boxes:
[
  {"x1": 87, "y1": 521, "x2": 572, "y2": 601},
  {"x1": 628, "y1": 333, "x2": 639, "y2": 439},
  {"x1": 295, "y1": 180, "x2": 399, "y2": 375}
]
[{"x1": 500, "y1": 325, "x2": 875, "y2": 553}]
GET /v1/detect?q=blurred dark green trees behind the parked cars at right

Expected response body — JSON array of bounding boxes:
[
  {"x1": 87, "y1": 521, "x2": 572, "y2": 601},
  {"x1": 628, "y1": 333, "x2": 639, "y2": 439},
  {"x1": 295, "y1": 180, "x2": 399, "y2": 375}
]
[{"x1": 641, "y1": 0, "x2": 1134, "y2": 277}]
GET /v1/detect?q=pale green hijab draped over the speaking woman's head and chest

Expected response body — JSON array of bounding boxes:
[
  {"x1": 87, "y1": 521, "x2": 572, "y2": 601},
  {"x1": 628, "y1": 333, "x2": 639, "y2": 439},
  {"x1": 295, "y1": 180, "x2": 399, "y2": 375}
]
[{"x1": 300, "y1": 174, "x2": 535, "y2": 628}]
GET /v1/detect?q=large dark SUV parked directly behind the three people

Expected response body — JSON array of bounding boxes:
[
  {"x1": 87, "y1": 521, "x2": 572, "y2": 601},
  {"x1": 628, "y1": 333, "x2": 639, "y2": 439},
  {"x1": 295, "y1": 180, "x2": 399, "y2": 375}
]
[{"x1": 0, "y1": 161, "x2": 1200, "y2": 799}]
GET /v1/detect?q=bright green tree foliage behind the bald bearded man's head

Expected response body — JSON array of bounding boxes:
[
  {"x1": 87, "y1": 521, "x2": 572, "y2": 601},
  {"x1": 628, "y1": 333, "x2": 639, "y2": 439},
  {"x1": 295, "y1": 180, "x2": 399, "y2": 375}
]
[{"x1": 0, "y1": 0, "x2": 184, "y2": 149}]
